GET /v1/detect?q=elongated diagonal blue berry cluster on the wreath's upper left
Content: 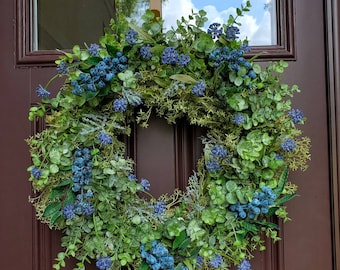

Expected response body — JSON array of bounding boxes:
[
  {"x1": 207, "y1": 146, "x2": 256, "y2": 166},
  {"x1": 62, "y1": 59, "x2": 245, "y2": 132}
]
[{"x1": 71, "y1": 52, "x2": 127, "y2": 95}]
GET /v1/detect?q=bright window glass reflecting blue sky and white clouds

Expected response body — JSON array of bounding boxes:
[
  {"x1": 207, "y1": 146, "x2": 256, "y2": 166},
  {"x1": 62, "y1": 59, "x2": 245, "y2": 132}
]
[{"x1": 162, "y1": 0, "x2": 277, "y2": 46}]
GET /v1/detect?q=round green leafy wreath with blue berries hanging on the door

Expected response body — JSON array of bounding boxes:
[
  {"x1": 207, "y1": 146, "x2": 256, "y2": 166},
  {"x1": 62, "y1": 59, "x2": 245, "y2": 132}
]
[{"x1": 27, "y1": 2, "x2": 310, "y2": 270}]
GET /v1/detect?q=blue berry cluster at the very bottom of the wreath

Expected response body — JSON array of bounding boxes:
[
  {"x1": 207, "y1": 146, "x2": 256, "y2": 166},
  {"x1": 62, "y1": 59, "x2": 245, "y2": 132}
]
[{"x1": 140, "y1": 241, "x2": 175, "y2": 270}]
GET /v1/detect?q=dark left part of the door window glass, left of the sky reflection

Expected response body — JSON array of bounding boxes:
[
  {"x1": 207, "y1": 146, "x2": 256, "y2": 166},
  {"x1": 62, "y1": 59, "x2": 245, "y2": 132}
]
[{"x1": 33, "y1": 0, "x2": 149, "y2": 51}]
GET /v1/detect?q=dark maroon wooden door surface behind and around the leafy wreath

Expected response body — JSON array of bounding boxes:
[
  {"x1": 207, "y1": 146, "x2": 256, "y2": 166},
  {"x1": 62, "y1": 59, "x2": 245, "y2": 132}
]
[{"x1": 0, "y1": 0, "x2": 339, "y2": 270}]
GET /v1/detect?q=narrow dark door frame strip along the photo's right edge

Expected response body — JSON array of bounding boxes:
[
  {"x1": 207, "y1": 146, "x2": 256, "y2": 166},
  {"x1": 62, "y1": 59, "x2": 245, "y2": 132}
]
[{"x1": 325, "y1": 0, "x2": 340, "y2": 269}]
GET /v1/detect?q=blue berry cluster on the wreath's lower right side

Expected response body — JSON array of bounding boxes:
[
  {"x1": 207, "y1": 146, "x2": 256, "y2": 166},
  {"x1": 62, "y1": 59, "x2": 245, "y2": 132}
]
[{"x1": 229, "y1": 186, "x2": 276, "y2": 219}]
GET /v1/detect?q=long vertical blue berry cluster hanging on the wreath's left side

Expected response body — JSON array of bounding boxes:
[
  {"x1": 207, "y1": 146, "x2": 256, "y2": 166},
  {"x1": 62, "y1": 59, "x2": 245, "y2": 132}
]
[{"x1": 62, "y1": 148, "x2": 94, "y2": 219}]
